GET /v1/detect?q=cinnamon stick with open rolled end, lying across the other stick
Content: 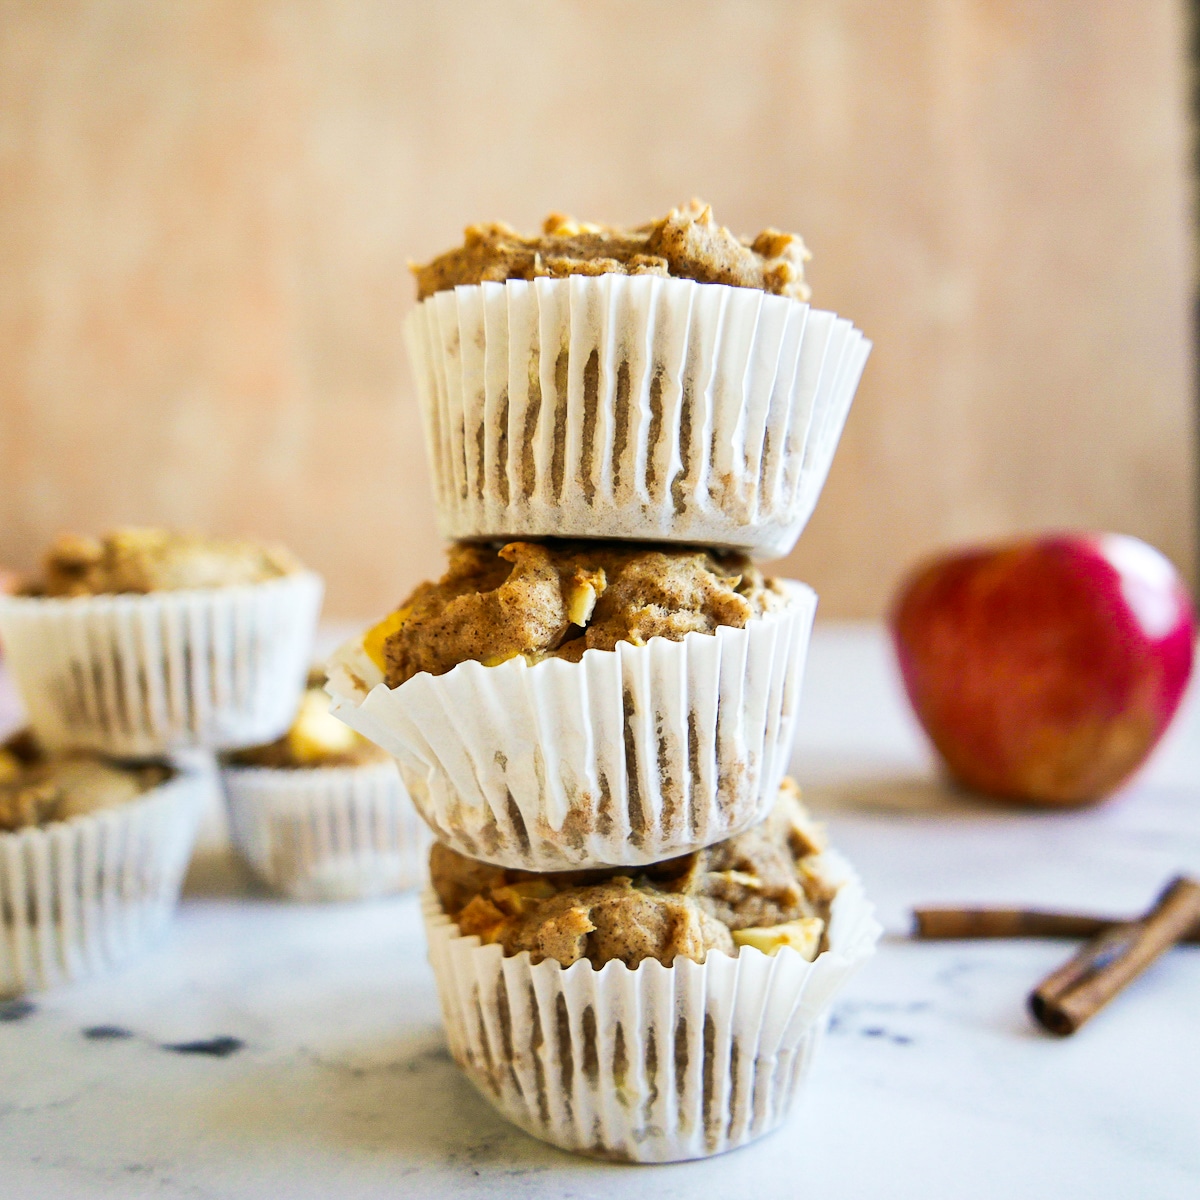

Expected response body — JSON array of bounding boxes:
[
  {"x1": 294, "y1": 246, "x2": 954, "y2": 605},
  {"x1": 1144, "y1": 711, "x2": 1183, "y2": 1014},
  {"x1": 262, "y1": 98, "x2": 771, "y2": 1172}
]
[{"x1": 1030, "y1": 876, "x2": 1200, "y2": 1037}]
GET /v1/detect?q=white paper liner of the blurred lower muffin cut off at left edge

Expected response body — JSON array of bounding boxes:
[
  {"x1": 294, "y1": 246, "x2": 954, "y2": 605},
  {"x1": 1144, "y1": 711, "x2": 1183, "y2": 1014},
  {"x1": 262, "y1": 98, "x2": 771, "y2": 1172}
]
[{"x1": 0, "y1": 764, "x2": 208, "y2": 996}]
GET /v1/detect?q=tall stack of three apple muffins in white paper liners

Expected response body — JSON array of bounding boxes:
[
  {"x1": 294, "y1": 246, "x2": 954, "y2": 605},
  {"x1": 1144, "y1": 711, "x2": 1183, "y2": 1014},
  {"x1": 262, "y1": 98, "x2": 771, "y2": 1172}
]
[{"x1": 328, "y1": 203, "x2": 877, "y2": 1162}]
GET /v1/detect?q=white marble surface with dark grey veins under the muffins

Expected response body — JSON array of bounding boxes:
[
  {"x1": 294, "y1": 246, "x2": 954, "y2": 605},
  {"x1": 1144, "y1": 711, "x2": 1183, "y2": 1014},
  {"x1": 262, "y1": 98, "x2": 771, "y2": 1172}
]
[{"x1": 0, "y1": 626, "x2": 1200, "y2": 1200}]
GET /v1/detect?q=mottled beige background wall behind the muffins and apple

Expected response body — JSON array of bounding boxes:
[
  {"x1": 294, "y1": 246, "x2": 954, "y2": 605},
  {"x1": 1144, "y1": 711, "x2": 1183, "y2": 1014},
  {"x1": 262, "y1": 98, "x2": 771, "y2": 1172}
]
[{"x1": 0, "y1": 0, "x2": 1195, "y2": 617}]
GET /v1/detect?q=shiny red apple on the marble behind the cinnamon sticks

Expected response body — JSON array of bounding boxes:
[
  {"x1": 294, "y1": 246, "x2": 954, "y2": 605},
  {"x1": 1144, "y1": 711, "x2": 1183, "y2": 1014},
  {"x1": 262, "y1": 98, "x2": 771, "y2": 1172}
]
[{"x1": 892, "y1": 534, "x2": 1196, "y2": 805}]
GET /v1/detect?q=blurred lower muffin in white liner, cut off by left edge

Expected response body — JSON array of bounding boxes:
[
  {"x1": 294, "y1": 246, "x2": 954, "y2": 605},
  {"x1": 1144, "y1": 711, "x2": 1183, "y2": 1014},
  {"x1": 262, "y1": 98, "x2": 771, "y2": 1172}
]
[{"x1": 0, "y1": 734, "x2": 214, "y2": 996}]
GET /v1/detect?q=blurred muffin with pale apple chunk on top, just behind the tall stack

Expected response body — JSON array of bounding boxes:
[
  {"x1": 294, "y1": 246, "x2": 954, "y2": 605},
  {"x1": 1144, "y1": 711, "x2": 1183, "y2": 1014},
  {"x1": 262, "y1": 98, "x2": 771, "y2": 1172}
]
[{"x1": 221, "y1": 672, "x2": 430, "y2": 900}]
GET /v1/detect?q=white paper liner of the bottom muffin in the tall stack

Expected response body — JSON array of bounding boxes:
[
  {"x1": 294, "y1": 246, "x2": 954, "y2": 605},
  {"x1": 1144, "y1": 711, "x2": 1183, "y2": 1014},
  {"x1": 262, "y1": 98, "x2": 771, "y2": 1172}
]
[{"x1": 424, "y1": 854, "x2": 881, "y2": 1163}]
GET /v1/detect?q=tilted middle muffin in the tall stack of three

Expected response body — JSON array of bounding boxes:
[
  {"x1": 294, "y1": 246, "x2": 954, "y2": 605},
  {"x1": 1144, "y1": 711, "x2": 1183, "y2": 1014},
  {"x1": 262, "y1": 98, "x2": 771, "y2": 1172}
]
[{"x1": 329, "y1": 541, "x2": 816, "y2": 871}]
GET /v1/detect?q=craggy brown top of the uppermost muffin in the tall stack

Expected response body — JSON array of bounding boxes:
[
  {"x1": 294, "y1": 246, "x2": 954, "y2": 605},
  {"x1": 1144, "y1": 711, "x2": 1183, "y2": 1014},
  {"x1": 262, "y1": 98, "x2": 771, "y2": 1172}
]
[{"x1": 412, "y1": 200, "x2": 811, "y2": 300}]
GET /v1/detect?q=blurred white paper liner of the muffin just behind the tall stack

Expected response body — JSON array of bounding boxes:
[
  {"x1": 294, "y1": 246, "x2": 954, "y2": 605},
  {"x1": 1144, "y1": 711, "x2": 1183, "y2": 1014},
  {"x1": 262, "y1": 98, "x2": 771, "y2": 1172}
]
[{"x1": 221, "y1": 762, "x2": 430, "y2": 900}]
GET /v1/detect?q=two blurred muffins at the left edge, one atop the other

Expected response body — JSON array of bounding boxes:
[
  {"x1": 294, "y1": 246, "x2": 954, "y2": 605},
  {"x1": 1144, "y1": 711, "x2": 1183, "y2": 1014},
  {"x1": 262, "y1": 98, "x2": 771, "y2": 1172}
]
[{"x1": 0, "y1": 529, "x2": 322, "y2": 995}]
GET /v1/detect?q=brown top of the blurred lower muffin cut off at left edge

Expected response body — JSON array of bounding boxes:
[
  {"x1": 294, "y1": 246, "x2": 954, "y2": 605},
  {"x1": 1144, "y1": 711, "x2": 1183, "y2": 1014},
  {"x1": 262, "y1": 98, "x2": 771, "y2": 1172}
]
[{"x1": 0, "y1": 733, "x2": 170, "y2": 832}]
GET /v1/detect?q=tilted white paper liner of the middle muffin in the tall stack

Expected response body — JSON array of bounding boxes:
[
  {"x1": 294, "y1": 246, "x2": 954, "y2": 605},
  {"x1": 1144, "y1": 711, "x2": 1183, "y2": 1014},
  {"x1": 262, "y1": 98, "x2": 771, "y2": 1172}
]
[{"x1": 328, "y1": 582, "x2": 816, "y2": 871}]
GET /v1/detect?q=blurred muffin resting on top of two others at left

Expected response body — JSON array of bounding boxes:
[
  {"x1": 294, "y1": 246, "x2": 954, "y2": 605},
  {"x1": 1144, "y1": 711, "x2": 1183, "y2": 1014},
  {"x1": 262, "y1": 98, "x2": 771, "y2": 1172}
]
[{"x1": 0, "y1": 529, "x2": 322, "y2": 758}]
